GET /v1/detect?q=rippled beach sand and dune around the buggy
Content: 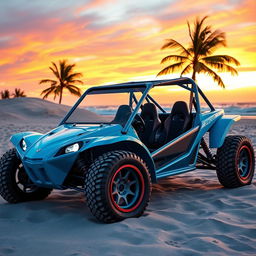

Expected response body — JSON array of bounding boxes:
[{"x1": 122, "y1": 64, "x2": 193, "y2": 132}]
[{"x1": 0, "y1": 99, "x2": 256, "y2": 256}]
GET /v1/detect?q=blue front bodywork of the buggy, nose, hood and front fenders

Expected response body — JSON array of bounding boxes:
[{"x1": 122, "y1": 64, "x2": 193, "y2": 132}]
[{"x1": 11, "y1": 124, "x2": 152, "y2": 188}]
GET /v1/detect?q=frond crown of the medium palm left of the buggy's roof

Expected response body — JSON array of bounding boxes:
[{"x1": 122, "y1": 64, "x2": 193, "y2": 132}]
[{"x1": 39, "y1": 60, "x2": 83, "y2": 104}]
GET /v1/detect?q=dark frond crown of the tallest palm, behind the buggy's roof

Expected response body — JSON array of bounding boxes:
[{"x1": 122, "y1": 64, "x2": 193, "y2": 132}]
[{"x1": 157, "y1": 16, "x2": 240, "y2": 88}]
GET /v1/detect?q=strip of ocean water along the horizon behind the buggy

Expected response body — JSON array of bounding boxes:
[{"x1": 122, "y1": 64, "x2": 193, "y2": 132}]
[{"x1": 87, "y1": 102, "x2": 256, "y2": 119}]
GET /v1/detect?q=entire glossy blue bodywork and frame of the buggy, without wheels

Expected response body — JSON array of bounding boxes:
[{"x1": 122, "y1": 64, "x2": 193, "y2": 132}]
[{"x1": 7, "y1": 78, "x2": 237, "y2": 189}]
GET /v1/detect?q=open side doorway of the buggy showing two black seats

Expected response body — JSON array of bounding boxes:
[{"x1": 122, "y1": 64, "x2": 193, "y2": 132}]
[{"x1": 136, "y1": 85, "x2": 196, "y2": 151}]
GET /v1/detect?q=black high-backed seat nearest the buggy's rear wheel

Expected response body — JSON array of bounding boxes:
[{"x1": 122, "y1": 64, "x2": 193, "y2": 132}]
[{"x1": 164, "y1": 101, "x2": 191, "y2": 143}]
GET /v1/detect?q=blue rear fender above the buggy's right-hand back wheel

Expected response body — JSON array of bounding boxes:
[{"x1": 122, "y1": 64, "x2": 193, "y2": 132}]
[{"x1": 209, "y1": 115, "x2": 241, "y2": 148}]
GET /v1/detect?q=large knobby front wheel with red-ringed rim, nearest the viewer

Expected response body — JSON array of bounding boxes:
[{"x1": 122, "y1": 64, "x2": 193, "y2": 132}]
[{"x1": 85, "y1": 150, "x2": 152, "y2": 223}]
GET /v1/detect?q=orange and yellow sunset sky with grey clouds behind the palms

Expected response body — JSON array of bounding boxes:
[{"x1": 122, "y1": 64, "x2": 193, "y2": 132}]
[{"x1": 0, "y1": 0, "x2": 256, "y2": 104}]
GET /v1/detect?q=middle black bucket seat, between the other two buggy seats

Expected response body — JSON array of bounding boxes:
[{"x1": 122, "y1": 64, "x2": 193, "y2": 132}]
[{"x1": 139, "y1": 103, "x2": 161, "y2": 148}]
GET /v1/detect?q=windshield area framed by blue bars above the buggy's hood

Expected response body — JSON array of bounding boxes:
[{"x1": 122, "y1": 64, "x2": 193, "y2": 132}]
[{"x1": 65, "y1": 87, "x2": 145, "y2": 126}]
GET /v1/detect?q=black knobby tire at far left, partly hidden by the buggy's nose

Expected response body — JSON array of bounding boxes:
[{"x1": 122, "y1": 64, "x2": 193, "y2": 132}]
[{"x1": 0, "y1": 149, "x2": 52, "y2": 203}]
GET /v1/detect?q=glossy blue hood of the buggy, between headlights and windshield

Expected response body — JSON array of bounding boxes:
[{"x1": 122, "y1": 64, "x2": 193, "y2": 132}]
[{"x1": 25, "y1": 124, "x2": 122, "y2": 159}]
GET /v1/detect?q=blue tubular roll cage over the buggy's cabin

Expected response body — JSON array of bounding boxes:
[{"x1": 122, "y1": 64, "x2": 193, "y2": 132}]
[{"x1": 59, "y1": 77, "x2": 215, "y2": 130}]
